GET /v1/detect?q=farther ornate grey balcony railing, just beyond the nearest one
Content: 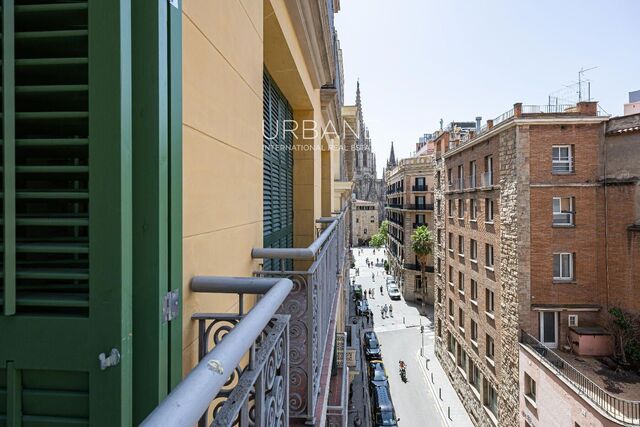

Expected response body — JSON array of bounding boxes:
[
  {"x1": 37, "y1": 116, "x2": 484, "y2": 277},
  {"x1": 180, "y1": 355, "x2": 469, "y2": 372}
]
[{"x1": 252, "y1": 210, "x2": 348, "y2": 424}]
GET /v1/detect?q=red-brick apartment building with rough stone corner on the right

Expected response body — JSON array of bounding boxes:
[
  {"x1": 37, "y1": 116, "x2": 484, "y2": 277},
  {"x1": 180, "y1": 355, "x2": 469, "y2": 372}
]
[{"x1": 434, "y1": 102, "x2": 638, "y2": 426}]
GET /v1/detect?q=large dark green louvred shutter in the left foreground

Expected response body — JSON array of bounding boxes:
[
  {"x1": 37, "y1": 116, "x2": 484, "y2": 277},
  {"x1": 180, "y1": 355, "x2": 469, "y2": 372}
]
[{"x1": 0, "y1": 0, "x2": 132, "y2": 426}]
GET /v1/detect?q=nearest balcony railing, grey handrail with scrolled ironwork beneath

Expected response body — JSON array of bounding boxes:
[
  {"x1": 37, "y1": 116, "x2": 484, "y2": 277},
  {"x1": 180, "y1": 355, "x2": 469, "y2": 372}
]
[{"x1": 141, "y1": 277, "x2": 293, "y2": 427}]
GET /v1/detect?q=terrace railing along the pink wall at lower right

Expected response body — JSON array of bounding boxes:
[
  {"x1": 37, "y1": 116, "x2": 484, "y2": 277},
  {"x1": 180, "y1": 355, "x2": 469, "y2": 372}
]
[{"x1": 520, "y1": 331, "x2": 640, "y2": 425}]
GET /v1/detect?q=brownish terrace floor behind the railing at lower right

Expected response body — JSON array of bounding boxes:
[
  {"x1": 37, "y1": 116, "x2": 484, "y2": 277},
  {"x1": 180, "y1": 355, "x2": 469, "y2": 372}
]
[{"x1": 555, "y1": 350, "x2": 640, "y2": 400}]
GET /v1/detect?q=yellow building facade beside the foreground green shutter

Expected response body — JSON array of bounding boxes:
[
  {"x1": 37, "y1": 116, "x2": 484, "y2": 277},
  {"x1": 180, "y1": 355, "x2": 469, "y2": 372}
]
[{"x1": 182, "y1": 0, "x2": 351, "y2": 424}]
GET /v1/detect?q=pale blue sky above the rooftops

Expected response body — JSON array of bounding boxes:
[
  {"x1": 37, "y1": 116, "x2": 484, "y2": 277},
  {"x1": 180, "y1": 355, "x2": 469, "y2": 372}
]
[{"x1": 336, "y1": 0, "x2": 640, "y2": 173}]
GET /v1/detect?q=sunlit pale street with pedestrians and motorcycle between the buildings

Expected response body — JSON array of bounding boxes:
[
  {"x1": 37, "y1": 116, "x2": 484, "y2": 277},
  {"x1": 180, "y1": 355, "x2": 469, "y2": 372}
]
[{"x1": 351, "y1": 248, "x2": 447, "y2": 427}]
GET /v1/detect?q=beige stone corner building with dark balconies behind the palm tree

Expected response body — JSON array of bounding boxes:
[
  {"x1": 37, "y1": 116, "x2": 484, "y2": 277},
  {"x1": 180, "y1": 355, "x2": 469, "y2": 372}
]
[{"x1": 385, "y1": 155, "x2": 435, "y2": 304}]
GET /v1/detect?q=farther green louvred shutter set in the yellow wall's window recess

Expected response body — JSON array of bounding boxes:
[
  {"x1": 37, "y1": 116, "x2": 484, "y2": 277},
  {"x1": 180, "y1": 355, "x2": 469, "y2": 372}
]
[{"x1": 263, "y1": 70, "x2": 293, "y2": 270}]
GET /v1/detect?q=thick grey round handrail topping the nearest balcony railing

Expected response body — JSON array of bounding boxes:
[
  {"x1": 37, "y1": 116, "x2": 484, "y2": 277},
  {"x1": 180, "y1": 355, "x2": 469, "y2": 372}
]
[{"x1": 141, "y1": 277, "x2": 293, "y2": 427}]
